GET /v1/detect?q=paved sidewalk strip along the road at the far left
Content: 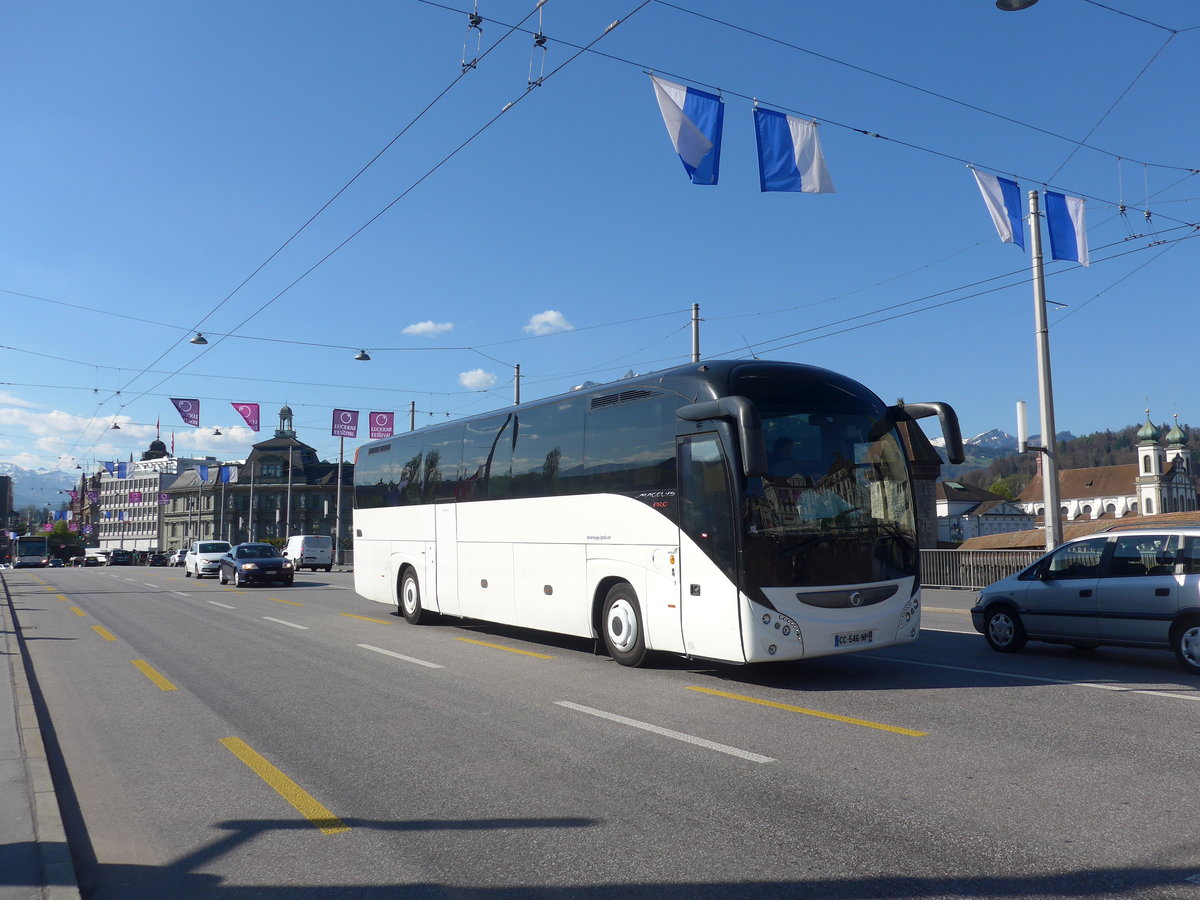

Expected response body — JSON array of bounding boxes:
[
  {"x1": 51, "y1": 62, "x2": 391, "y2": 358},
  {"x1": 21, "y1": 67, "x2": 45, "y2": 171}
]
[{"x1": 0, "y1": 571, "x2": 79, "y2": 900}]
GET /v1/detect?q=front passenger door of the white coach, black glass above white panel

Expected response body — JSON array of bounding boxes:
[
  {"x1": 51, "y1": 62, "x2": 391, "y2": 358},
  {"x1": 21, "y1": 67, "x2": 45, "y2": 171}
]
[{"x1": 677, "y1": 432, "x2": 744, "y2": 659}]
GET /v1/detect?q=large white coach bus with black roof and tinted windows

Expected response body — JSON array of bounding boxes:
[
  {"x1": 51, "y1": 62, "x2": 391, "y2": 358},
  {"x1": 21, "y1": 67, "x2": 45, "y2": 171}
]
[{"x1": 354, "y1": 360, "x2": 962, "y2": 666}]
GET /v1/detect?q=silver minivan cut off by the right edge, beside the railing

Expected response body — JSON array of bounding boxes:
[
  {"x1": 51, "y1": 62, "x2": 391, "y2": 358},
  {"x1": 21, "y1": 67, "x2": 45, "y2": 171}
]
[{"x1": 971, "y1": 527, "x2": 1200, "y2": 674}]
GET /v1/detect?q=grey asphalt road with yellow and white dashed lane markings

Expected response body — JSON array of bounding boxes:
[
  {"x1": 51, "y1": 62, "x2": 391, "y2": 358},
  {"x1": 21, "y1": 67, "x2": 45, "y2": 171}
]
[{"x1": 5, "y1": 568, "x2": 1200, "y2": 900}]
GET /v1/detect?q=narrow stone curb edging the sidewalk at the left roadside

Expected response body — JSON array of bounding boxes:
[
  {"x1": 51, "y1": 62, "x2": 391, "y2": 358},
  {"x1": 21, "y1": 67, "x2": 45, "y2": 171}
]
[{"x1": 0, "y1": 580, "x2": 79, "y2": 900}]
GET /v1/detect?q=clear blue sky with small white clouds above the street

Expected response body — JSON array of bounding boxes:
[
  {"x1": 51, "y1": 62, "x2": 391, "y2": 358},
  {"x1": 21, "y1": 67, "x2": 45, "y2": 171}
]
[{"x1": 0, "y1": 0, "x2": 1200, "y2": 469}]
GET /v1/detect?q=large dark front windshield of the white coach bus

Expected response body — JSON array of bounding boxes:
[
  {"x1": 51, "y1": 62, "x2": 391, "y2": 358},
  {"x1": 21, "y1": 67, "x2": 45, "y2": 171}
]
[{"x1": 742, "y1": 408, "x2": 917, "y2": 587}]
